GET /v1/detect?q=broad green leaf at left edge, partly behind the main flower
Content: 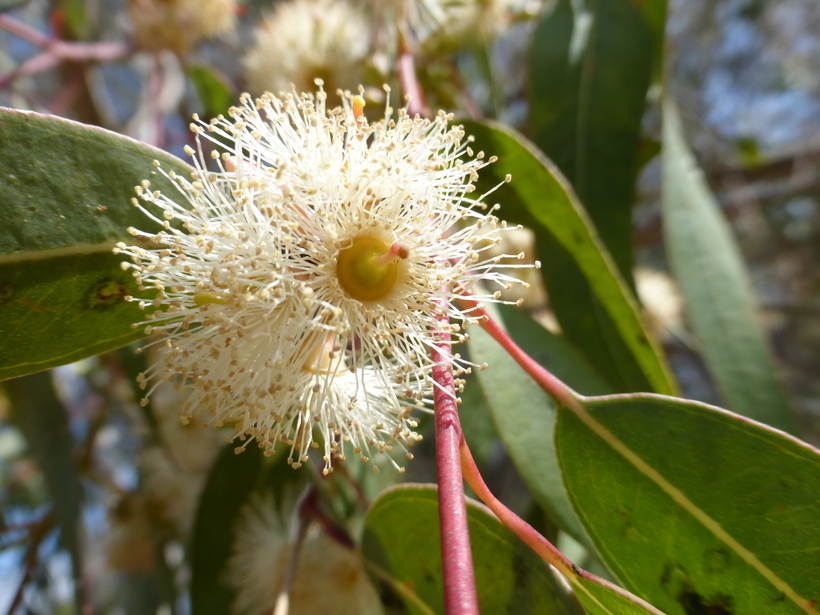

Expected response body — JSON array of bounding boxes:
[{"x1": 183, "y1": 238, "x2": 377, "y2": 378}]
[{"x1": 0, "y1": 108, "x2": 192, "y2": 379}]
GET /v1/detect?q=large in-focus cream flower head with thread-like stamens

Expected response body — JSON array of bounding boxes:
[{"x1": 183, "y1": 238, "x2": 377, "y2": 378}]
[{"x1": 117, "y1": 84, "x2": 526, "y2": 472}]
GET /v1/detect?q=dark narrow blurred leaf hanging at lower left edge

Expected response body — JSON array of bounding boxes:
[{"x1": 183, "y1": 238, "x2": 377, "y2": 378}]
[{"x1": 5, "y1": 372, "x2": 83, "y2": 607}]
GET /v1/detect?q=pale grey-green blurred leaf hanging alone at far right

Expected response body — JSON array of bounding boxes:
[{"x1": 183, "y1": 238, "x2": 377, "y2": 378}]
[{"x1": 662, "y1": 102, "x2": 797, "y2": 433}]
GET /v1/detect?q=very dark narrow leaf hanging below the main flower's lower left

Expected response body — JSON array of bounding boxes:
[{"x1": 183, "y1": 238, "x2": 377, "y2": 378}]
[{"x1": 190, "y1": 444, "x2": 263, "y2": 615}]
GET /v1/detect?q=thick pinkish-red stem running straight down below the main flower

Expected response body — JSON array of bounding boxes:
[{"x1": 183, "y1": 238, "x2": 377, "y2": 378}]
[{"x1": 431, "y1": 316, "x2": 478, "y2": 615}]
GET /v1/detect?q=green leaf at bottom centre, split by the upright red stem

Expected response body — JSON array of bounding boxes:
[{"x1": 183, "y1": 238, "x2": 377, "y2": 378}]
[{"x1": 362, "y1": 484, "x2": 583, "y2": 615}]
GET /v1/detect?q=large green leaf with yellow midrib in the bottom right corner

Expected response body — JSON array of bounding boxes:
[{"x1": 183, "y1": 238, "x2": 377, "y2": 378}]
[{"x1": 555, "y1": 394, "x2": 820, "y2": 615}]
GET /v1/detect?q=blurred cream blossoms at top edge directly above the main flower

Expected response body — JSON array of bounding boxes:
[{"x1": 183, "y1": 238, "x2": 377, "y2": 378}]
[{"x1": 242, "y1": 0, "x2": 533, "y2": 93}]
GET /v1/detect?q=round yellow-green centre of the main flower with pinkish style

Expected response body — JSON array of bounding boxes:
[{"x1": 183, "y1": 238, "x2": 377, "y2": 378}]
[{"x1": 336, "y1": 236, "x2": 408, "y2": 301}]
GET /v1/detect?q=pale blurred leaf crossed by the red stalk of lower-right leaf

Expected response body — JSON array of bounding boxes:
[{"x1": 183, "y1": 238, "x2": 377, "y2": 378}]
[{"x1": 462, "y1": 309, "x2": 610, "y2": 545}]
